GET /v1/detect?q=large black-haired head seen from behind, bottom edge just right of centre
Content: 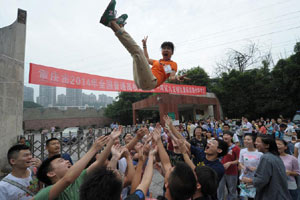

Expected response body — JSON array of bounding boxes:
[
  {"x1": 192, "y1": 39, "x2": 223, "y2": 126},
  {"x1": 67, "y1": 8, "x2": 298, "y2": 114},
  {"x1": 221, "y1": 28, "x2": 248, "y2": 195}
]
[{"x1": 168, "y1": 162, "x2": 196, "y2": 200}]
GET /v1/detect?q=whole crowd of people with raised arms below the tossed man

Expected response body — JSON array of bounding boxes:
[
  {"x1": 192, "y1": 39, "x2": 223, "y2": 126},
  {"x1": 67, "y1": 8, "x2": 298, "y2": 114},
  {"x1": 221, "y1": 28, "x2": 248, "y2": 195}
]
[{"x1": 0, "y1": 116, "x2": 300, "y2": 200}]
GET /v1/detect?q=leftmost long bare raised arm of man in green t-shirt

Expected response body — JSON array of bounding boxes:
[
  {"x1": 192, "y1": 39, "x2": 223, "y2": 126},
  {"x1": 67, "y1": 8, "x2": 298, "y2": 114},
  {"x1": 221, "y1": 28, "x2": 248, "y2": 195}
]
[{"x1": 49, "y1": 136, "x2": 107, "y2": 200}]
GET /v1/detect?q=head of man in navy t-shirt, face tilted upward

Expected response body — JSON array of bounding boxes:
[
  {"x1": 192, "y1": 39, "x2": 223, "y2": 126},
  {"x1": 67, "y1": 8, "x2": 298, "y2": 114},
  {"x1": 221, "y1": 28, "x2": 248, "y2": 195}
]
[{"x1": 204, "y1": 139, "x2": 228, "y2": 158}]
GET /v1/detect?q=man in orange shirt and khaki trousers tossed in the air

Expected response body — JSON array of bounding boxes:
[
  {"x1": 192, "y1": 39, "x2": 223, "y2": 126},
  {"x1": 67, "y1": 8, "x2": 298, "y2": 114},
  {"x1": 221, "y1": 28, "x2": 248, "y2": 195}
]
[{"x1": 100, "y1": 0, "x2": 187, "y2": 90}]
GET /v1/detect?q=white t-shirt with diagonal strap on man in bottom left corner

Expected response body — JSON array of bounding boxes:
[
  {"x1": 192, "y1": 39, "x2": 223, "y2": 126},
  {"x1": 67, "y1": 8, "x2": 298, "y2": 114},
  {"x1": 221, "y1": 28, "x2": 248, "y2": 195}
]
[{"x1": 0, "y1": 170, "x2": 34, "y2": 200}]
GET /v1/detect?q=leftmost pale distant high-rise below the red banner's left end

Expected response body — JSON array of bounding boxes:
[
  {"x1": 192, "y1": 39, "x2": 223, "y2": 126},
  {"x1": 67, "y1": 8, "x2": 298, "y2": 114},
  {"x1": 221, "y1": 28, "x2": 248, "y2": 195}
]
[{"x1": 37, "y1": 85, "x2": 56, "y2": 107}]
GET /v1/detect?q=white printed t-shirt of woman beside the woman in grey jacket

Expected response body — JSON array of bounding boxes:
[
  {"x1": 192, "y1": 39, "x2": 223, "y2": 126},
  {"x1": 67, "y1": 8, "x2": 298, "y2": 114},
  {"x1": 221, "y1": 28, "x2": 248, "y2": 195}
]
[{"x1": 239, "y1": 148, "x2": 263, "y2": 179}]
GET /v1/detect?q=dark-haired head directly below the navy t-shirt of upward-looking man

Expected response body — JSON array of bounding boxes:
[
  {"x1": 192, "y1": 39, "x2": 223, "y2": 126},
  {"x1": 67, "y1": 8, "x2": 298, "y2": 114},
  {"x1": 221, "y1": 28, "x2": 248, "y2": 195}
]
[{"x1": 195, "y1": 166, "x2": 219, "y2": 196}]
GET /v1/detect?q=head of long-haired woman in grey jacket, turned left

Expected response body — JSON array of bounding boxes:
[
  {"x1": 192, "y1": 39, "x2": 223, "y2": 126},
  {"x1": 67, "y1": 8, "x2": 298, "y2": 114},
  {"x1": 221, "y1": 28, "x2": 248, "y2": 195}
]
[{"x1": 255, "y1": 134, "x2": 279, "y2": 156}]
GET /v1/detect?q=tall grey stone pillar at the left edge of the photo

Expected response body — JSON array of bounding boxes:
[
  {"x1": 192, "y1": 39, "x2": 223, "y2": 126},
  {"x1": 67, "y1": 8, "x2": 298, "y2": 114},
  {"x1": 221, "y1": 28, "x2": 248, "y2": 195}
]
[{"x1": 0, "y1": 9, "x2": 26, "y2": 172}]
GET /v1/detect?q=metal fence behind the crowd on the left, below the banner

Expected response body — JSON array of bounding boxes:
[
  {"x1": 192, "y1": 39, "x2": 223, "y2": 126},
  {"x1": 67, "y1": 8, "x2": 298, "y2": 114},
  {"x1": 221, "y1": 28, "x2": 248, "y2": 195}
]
[{"x1": 18, "y1": 126, "x2": 139, "y2": 161}]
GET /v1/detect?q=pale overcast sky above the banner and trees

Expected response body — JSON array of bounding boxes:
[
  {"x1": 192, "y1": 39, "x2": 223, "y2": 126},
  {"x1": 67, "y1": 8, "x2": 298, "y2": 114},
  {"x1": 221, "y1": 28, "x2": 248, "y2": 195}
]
[{"x1": 0, "y1": 0, "x2": 300, "y2": 100}]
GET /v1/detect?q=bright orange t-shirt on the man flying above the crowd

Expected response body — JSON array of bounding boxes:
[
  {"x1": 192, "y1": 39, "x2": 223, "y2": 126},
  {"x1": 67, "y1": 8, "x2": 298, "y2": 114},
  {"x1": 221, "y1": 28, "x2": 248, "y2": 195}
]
[{"x1": 151, "y1": 60, "x2": 177, "y2": 87}]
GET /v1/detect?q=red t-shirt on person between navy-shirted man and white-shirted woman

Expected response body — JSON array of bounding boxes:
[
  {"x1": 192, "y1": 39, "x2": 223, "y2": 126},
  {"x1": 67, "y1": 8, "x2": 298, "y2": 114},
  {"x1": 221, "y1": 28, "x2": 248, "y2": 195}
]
[{"x1": 221, "y1": 145, "x2": 240, "y2": 175}]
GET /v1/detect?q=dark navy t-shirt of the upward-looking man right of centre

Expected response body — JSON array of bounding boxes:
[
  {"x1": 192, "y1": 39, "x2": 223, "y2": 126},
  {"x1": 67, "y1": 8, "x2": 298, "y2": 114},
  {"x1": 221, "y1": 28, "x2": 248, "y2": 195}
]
[{"x1": 191, "y1": 145, "x2": 225, "y2": 182}]
